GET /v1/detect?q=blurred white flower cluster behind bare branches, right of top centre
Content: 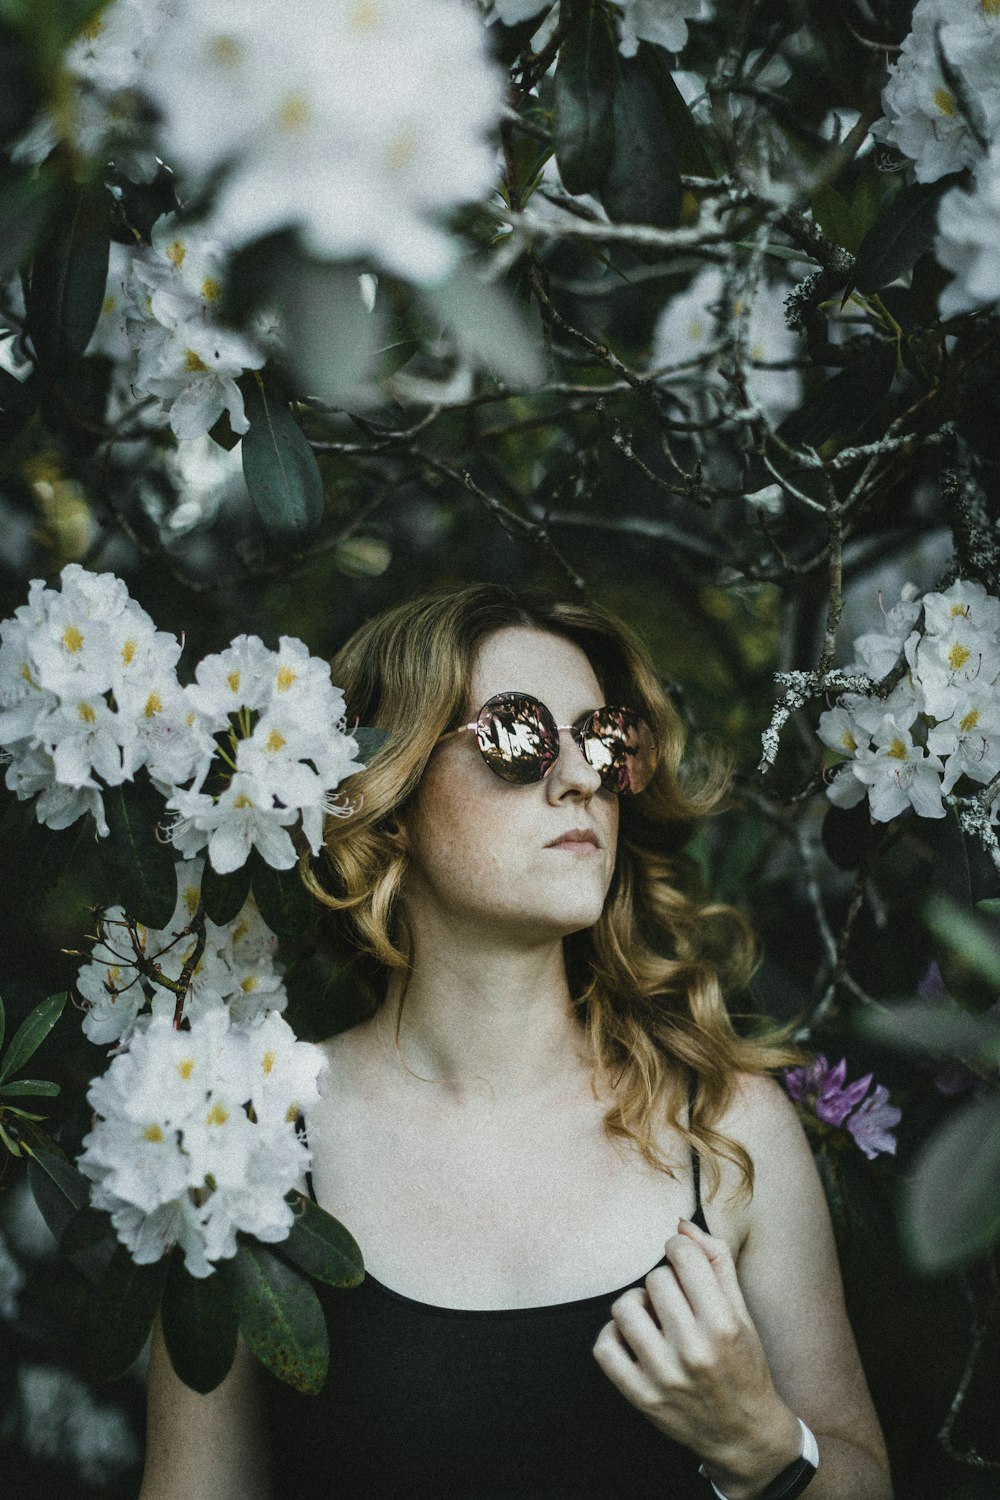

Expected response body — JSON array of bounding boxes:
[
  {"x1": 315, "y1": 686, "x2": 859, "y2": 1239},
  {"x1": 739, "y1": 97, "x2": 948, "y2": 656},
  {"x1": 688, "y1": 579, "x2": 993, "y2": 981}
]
[{"x1": 652, "y1": 266, "x2": 802, "y2": 425}]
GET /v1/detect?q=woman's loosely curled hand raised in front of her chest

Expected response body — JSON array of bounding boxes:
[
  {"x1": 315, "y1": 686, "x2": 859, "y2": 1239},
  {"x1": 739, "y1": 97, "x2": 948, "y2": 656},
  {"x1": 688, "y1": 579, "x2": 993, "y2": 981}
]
[{"x1": 594, "y1": 1220, "x2": 801, "y2": 1500}]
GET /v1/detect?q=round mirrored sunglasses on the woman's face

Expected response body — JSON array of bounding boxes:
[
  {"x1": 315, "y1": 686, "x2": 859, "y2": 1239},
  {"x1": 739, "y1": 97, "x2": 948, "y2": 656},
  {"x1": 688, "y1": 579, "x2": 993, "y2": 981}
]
[{"x1": 441, "y1": 693, "x2": 657, "y2": 797}]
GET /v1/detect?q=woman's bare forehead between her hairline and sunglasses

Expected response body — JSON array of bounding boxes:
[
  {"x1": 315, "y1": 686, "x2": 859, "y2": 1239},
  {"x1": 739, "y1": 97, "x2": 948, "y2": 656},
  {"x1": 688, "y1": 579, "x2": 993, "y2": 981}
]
[{"x1": 469, "y1": 626, "x2": 603, "y2": 711}]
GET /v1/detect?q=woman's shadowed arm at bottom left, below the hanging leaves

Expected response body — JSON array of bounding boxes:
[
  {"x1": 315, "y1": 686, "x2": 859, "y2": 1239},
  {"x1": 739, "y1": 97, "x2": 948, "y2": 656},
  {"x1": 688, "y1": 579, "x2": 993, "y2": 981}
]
[{"x1": 139, "y1": 1322, "x2": 270, "y2": 1500}]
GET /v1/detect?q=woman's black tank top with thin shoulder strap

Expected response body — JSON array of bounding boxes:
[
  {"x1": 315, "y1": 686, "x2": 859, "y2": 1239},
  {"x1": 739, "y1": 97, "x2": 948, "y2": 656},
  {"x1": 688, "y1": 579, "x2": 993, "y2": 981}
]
[{"x1": 264, "y1": 1110, "x2": 708, "y2": 1500}]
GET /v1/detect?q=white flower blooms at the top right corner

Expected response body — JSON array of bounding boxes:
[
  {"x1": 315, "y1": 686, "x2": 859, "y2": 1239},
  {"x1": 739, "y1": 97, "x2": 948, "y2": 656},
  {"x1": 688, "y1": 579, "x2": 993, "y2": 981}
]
[{"x1": 874, "y1": 0, "x2": 1000, "y2": 318}]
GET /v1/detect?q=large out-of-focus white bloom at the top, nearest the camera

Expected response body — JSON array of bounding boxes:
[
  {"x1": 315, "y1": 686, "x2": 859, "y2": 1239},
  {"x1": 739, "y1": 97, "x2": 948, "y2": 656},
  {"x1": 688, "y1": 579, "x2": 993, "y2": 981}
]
[{"x1": 144, "y1": 0, "x2": 504, "y2": 281}]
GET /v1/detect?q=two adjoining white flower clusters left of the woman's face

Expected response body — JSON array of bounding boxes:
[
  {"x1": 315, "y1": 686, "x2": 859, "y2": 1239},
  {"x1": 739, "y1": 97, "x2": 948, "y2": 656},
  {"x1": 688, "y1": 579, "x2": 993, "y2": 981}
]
[{"x1": 0, "y1": 563, "x2": 361, "y2": 873}]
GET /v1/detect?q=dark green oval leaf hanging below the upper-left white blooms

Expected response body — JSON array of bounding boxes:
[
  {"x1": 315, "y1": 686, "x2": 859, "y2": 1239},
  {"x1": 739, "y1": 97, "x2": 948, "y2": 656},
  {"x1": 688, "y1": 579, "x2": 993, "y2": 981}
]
[{"x1": 243, "y1": 372, "x2": 324, "y2": 545}]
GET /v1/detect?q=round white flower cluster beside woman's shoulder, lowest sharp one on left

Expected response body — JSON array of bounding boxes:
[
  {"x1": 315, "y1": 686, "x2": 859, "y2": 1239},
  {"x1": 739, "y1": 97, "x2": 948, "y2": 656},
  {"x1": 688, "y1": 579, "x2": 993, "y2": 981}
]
[{"x1": 78, "y1": 1010, "x2": 325, "y2": 1277}]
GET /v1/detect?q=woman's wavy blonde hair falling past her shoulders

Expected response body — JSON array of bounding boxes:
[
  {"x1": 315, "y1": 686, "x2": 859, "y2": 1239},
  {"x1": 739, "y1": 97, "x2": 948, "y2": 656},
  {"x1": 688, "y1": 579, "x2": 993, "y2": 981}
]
[{"x1": 303, "y1": 584, "x2": 799, "y2": 1193}]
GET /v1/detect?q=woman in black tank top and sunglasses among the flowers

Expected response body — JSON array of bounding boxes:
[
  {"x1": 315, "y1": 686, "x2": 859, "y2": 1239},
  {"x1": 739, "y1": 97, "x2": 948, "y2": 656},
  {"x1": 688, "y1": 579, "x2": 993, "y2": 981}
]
[{"x1": 141, "y1": 585, "x2": 891, "y2": 1500}]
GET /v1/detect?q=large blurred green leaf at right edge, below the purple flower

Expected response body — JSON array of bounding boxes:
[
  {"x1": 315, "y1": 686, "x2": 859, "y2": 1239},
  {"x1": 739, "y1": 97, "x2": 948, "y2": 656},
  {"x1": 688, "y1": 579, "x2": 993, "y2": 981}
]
[{"x1": 903, "y1": 1091, "x2": 1000, "y2": 1275}]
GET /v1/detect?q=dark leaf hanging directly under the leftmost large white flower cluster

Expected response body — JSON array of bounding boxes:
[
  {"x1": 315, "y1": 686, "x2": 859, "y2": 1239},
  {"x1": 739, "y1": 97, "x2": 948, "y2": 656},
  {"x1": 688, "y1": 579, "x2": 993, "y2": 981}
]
[{"x1": 100, "y1": 780, "x2": 177, "y2": 927}]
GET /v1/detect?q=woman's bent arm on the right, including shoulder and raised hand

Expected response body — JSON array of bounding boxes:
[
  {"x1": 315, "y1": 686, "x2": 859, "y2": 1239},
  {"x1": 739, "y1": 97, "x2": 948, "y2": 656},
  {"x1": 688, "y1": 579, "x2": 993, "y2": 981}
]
[{"x1": 594, "y1": 1079, "x2": 892, "y2": 1500}]
